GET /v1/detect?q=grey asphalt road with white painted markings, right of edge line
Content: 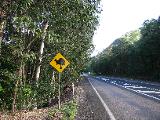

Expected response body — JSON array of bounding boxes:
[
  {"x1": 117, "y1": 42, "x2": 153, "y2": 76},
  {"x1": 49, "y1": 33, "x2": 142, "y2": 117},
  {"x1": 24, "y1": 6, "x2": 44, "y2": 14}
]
[{"x1": 87, "y1": 76, "x2": 160, "y2": 120}]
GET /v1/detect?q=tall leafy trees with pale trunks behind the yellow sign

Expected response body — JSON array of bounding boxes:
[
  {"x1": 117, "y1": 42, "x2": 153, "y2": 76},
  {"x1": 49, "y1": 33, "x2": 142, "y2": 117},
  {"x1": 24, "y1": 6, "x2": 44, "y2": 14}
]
[{"x1": 0, "y1": 0, "x2": 101, "y2": 112}]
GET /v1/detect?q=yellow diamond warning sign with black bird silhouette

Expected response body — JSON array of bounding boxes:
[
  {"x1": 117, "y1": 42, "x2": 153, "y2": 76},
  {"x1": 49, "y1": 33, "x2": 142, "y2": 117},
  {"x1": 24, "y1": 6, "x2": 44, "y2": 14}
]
[{"x1": 50, "y1": 53, "x2": 69, "y2": 72}]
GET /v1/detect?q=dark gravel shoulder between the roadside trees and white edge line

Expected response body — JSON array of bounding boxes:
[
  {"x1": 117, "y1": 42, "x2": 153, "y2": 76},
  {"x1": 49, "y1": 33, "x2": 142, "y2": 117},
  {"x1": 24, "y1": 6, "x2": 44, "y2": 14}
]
[{"x1": 76, "y1": 77, "x2": 109, "y2": 120}]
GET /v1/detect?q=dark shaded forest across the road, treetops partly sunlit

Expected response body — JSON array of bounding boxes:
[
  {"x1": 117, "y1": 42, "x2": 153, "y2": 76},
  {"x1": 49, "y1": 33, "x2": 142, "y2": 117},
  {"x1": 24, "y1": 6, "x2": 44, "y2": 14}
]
[{"x1": 89, "y1": 17, "x2": 160, "y2": 81}]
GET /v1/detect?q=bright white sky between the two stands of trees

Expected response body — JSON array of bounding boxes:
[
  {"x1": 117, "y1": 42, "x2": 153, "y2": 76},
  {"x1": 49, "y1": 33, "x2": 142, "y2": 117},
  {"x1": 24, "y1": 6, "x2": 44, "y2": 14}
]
[{"x1": 92, "y1": 0, "x2": 160, "y2": 56}]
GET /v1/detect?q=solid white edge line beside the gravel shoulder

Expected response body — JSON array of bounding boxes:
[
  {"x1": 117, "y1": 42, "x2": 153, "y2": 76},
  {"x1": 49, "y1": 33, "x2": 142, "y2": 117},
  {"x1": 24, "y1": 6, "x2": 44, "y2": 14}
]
[{"x1": 88, "y1": 79, "x2": 116, "y2": 120}]
